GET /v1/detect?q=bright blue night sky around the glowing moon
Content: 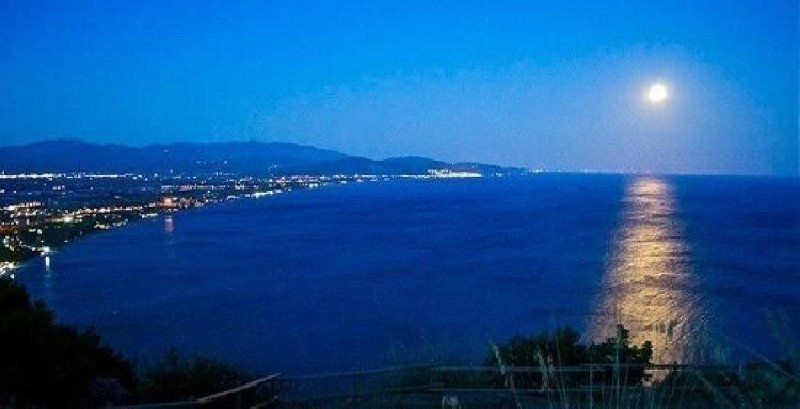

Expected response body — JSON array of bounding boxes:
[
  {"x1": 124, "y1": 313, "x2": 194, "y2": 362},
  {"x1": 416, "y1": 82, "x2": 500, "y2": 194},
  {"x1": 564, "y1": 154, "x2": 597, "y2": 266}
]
[{"x1": 0, "y1": 0, "x2": 800, "y2": 175}]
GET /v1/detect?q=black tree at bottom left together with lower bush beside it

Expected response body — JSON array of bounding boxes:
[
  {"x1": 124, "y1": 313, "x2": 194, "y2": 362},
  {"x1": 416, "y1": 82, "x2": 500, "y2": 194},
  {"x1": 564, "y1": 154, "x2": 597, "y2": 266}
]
[{"x1": 0, "y1": 277, "x2": 252, "y2": 408}]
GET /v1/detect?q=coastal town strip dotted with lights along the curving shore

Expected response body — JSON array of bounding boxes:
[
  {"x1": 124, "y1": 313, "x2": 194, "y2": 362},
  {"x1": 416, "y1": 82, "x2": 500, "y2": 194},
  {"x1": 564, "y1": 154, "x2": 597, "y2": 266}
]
[{"x1": 0, "y1": 169, "x2": 496, "y2": 274}]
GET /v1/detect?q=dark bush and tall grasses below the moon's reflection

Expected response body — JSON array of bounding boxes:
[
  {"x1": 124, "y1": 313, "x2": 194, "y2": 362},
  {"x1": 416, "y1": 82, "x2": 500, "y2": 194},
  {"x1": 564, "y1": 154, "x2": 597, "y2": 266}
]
[{"x1": 478, "y1": 326, "x2": 800, "y2": 408}]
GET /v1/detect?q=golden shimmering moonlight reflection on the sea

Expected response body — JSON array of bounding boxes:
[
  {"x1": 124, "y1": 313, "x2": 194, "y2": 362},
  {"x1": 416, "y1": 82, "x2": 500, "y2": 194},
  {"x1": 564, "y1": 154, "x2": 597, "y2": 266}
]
[{"x1": 590, "y1": 177, "x2": 702, "y2": 363}]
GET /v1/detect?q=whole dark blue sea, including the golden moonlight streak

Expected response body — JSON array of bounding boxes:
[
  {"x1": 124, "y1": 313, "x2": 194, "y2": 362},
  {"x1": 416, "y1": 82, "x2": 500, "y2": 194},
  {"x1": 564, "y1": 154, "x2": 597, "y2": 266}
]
[{"x1": 12, "y1": 175, "x2": 800, "y2": 373}]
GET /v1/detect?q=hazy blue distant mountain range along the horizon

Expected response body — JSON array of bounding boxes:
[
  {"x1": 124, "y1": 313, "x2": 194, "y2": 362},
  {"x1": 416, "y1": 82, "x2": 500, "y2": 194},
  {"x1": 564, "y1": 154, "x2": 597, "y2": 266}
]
[{"x1": 0, "y1": 139, "x2": 525, "y2": 175}]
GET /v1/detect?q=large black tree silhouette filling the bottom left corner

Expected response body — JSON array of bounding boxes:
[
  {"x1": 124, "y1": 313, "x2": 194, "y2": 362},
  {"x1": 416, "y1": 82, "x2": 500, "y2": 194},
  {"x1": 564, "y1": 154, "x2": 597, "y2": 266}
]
[{"x1": 0, "y1": 277, "x2": 135, "y2": 407}]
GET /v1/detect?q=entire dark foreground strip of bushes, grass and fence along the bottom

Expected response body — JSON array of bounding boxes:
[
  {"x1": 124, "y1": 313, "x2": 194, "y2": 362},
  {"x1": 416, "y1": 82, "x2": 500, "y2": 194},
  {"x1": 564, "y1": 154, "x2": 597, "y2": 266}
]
[{"x1": 0, "y1": 277, "x2": 800, "y2": 409}]
